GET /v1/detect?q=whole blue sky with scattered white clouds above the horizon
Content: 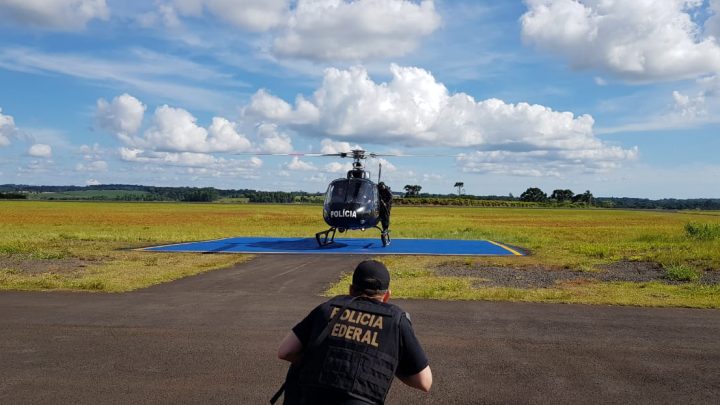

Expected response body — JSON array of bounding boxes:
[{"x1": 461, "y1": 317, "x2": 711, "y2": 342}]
[{"x1": 0, "y1": 0, "x2": 720, "y2": 198}]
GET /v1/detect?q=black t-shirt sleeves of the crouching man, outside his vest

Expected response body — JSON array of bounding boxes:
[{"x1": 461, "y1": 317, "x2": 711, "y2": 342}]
[{"x1": 292, "y1": 294, "x2": 428, "y2": 377}]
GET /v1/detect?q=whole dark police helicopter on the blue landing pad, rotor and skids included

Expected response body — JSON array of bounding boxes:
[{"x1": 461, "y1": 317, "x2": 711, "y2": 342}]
[{"x1": 315, "y1": 149, "x2": 392, "y2": 247}]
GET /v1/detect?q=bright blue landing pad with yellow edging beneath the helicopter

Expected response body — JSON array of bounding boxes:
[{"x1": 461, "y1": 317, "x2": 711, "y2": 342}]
[{"x1": 141, "y1": 238, "x2": 524, "y2": 256}]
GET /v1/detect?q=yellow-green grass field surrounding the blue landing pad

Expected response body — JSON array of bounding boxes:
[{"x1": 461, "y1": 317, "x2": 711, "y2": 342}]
[{"x1": 0, "y1": 201, "x2": 720, "y2": 308}]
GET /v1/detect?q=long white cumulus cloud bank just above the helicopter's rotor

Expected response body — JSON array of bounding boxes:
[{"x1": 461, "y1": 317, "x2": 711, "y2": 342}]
[{"x1": 253, "y1": 65, "x2": 637, "y2": 174}]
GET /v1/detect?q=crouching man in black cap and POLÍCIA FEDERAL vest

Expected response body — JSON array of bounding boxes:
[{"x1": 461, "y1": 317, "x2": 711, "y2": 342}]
[{"x1": 278, "y1": 260, "x2": 432, "y2": 404}]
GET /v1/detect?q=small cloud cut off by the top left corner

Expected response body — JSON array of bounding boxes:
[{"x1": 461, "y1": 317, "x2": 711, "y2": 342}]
[{"x1": 0, "y1": 0, "x2": 110, "y2": 31}]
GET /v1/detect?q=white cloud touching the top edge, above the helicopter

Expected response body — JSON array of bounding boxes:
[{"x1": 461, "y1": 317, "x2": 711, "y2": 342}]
[{"x1": 273, "y1": 0, "x2": 441, "y2": 61}]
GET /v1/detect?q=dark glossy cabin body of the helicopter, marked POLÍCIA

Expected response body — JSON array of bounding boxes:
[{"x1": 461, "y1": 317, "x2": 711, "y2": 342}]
[{"x1": 323, "y1": 176, "x2": 380, "y2": 231}]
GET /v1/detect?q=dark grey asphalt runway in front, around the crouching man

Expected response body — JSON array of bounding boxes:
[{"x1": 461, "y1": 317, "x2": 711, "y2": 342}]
[{"x1": 0, "y1": 255, "x2": 720, "y2": 404}]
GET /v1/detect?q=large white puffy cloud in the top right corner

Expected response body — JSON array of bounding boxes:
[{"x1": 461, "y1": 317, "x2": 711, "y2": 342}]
[{"x1": 521, "y1": 0, "x2": 720, "y2": 82}]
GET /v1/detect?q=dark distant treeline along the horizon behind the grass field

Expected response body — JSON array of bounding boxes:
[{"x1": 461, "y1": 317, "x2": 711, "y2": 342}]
[{"x1": 0, "y1": 184, "x2": 720, "y2": 210}]
